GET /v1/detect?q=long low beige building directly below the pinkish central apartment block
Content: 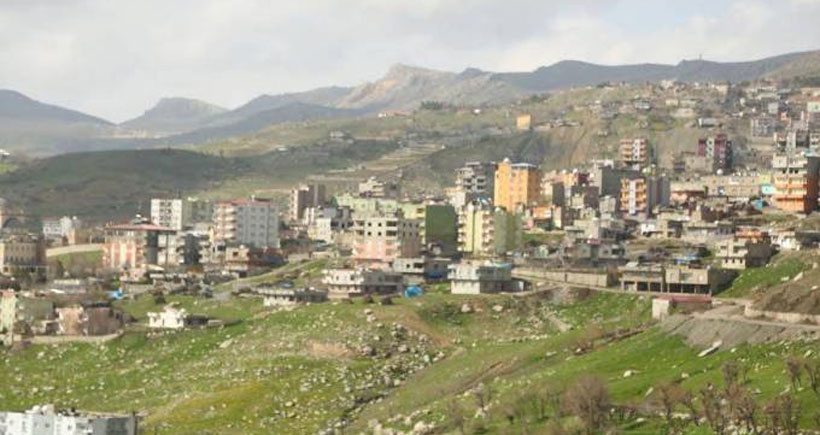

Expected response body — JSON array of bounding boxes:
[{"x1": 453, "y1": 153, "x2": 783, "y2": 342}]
[{"x1": 322, "y1": 268, "x2": 404, "y2": 299}]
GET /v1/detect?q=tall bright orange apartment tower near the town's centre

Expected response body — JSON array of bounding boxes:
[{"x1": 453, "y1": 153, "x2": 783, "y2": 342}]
[{"x1": 493, "y1": 159, "x2": 542, "y2": 212}]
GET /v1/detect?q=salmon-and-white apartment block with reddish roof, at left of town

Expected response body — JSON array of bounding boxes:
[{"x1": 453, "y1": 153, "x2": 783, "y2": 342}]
[{"x1": 103, "y1": 222, "x2": 179, "y2": 279}]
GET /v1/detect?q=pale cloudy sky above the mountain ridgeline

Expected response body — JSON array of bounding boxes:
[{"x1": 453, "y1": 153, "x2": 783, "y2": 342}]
[{"x1": 0, "y1": 0, "x2": 820, "y2": 122}]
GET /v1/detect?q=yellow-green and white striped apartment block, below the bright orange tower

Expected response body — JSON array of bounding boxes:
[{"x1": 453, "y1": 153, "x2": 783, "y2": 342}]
[{"x1": 458, "y1": 202, "x2": 523, "y2": 257}]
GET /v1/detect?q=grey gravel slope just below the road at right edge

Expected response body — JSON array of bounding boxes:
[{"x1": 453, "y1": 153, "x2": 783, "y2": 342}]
[{"x1": 661, "y1": 315, "x2": 812, "y2": 350}]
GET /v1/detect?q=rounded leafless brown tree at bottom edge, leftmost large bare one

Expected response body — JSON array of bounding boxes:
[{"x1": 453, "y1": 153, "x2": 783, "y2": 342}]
[{"x1": 563, "y1": 376, "x2": 610, "y2": 434}]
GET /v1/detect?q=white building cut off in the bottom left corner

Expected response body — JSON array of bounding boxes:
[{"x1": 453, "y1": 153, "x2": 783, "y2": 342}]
[{"x1": 0, "y1": 405, "x2": 139, "y2": 435}]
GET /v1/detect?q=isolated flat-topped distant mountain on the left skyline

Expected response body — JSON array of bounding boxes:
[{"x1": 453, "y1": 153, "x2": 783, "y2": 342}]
[{"x1": 120, "y1": 98, "x2": 228, "y2": 135}]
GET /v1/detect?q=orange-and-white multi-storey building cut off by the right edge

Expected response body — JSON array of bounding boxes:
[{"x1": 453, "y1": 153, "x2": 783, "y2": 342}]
[{"x1": 772, "y1": 154, "x2": 820, "y2": 214}]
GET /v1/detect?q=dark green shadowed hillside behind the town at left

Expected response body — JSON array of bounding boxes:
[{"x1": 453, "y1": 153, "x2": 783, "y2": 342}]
[{"x1": 0, "y1": 141, "x2": 397, "y2": 221}]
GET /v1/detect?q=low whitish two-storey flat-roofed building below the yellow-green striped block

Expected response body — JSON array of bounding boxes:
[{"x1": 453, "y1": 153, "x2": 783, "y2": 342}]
[{"x1": 449, "y1": 262, "x2": 520, "y2": 295}]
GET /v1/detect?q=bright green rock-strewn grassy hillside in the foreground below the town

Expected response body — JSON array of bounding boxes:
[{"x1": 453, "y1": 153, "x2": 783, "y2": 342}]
[{"x1": 0, "y1": 291, "x2": 820, "y2": 434}]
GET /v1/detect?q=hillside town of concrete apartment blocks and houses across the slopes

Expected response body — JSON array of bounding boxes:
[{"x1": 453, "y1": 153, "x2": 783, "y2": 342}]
[{"x1": 0, "y1": 75, "x2": 820, "y2": 433}]
